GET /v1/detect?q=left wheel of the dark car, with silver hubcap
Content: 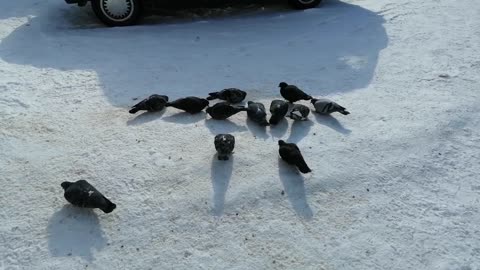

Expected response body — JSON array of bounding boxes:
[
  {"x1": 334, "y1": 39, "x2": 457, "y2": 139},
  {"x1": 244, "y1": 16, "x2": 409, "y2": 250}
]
[{"x1": 91, "y1": 0, "x2": 143, "y2": 26}]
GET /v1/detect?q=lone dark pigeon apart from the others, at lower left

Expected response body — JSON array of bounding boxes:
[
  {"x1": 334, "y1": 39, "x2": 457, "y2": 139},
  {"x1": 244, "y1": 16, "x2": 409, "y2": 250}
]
[{"x1": 62, "y1": 180, "x2": 117, "y2": 213}]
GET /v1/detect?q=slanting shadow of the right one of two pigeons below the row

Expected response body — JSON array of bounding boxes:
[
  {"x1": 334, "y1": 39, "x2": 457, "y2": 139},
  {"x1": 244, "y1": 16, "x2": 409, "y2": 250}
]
[{"x1": 278, "y1": 157, "x2": 313, "y2": 220}]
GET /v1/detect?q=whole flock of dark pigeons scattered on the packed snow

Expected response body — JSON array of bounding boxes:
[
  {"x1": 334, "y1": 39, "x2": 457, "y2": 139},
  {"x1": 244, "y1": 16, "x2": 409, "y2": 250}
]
[{"x1": 61, "y1": 82, "x2": 349, "y2": 213}]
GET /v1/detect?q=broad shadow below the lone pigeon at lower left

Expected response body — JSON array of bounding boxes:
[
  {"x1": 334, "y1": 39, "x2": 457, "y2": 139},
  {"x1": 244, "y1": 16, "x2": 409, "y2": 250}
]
[{"x1": 47, "y1": 205, "x2": 107, "y2": 261}]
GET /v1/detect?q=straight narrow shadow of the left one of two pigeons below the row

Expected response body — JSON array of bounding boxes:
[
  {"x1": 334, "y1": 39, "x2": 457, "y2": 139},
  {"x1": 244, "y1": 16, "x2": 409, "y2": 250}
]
[{"x1": 211, "y1": 154, "x2": 233, "y2": 216}]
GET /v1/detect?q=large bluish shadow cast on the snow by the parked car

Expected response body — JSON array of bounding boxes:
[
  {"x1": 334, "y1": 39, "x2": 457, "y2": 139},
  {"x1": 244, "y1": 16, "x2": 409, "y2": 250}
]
[{"x1": 0, "y1": 0, "x2": 388, "y2": 107}]
